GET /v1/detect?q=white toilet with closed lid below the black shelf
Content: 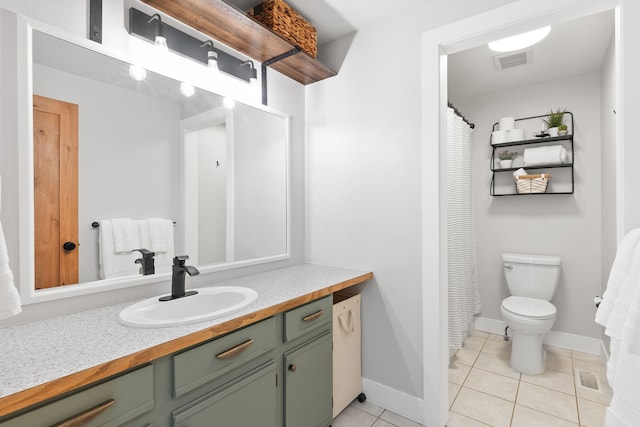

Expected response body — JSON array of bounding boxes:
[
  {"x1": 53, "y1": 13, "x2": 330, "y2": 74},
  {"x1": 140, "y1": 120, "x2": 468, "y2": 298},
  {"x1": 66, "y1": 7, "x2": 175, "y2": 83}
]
[{"x1": 500, "y1": 254, "x2": 562, "y2": 375}]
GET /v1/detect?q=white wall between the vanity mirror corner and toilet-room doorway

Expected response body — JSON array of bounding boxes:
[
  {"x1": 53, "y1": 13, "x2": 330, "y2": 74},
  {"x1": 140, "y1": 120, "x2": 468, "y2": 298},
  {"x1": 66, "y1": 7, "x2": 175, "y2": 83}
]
[{"x1": 307, "y1": 0, "x2": 507, "y2": 420}]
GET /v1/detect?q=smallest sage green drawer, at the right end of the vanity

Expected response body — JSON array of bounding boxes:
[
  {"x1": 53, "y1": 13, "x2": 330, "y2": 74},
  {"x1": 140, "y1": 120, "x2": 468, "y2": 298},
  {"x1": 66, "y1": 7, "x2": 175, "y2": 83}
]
[{"x1": 284, "y1": 295, "x2": 333, "y2": 342}]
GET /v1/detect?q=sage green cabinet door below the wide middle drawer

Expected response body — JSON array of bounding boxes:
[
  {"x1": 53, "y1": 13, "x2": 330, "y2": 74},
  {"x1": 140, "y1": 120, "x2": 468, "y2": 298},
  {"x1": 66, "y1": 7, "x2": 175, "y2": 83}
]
[{"x1": 173, "y1": 361, "x2": 276, "y2": 427}]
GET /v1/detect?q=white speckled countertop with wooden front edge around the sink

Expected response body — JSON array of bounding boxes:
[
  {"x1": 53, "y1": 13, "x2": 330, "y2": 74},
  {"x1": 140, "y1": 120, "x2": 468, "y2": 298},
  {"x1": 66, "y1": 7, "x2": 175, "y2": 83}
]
[{"x1": 0, "y1": 264, "x2": 369, "y2": 406}]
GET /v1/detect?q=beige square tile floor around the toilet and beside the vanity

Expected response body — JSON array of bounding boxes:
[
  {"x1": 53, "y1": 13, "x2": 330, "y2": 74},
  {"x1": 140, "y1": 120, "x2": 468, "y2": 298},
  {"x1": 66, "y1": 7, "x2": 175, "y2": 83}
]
[{"x1": 332, "y1": 331, "x2": 611, "y2": 427}]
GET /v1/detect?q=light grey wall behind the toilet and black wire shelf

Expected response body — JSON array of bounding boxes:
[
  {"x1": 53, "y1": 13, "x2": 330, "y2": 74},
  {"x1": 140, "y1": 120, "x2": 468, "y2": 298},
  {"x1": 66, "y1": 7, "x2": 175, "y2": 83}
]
[{"x1": 456, "y1": 72, "x2": 614, "y2": 338}]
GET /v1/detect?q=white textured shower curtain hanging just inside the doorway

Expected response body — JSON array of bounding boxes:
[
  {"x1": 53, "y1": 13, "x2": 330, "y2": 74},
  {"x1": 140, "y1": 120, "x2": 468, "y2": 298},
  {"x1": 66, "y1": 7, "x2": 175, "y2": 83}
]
[{"x1": 447, "y1": 108, "x2": 480, "y2": 356}]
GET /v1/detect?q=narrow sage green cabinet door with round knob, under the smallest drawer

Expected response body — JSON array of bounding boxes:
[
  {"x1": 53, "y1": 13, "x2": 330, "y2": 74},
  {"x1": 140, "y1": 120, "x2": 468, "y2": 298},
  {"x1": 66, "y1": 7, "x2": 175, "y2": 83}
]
[{"x1": 284, "y1": 331, "x2": 333, "y2": 427}]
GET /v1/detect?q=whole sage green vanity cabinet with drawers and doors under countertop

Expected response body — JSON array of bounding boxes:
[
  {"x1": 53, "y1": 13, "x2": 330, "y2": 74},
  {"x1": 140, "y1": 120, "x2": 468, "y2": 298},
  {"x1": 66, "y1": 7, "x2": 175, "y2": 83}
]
[{"x1": 0, "y1": 296, "x2": 333, "y2": 427}]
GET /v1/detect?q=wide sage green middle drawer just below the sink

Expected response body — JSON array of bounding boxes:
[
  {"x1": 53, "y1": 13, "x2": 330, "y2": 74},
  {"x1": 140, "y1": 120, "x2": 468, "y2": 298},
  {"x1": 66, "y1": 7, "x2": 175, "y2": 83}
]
[{"x1": 173, "y1": 317, "x2": 276, "y2": 397}]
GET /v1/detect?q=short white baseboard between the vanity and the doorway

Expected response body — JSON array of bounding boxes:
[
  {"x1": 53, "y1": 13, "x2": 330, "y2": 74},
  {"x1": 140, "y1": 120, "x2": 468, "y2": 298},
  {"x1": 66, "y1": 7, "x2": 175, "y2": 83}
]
[{"x1": 362, "y1": 378, "x2": 424, "y2": 424}]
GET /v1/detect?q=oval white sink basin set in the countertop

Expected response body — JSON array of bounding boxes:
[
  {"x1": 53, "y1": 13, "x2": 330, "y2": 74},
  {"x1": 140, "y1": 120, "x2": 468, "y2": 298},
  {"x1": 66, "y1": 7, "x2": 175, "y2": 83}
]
[{"x1": 119, "y1": 286, "x2": 258, "y2": 328}]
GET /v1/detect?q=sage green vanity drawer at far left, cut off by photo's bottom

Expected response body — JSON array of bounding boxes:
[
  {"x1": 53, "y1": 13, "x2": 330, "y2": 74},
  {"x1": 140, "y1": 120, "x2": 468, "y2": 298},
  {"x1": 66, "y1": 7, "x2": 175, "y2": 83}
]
[{"x1": 0, "y1": 365, "x2": 154, "y2": 427}]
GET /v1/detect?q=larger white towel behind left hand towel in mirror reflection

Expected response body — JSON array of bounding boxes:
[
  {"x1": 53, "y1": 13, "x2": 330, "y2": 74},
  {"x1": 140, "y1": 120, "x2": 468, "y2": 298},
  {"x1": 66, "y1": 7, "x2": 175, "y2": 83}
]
[{"x1": 98, "y1": 219, "x2": 140, "y2": 279}]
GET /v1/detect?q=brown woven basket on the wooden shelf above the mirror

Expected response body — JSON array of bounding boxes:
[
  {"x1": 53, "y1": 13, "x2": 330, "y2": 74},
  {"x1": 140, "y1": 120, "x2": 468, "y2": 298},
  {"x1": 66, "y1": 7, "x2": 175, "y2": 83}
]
[{"x1": 247, "y1": 0, "x2": 318, "y2": 58}]
